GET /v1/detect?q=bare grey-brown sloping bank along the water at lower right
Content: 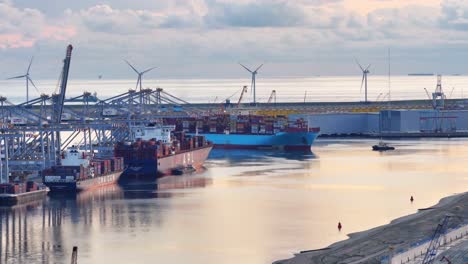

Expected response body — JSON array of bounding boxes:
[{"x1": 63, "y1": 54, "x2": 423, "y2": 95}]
[{"x1": 274, "y1": 193, "x2": 468, "y2": 264}]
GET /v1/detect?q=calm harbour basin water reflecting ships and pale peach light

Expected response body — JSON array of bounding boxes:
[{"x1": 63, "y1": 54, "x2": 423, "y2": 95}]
[{"x1": 0, "y1": 139, "x2": 468, "y2": 264}]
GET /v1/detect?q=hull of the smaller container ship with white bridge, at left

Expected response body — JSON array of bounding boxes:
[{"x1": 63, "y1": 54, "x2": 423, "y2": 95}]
[{"x1": 44, "y1": 171, "x2": 122, "y2": 193}]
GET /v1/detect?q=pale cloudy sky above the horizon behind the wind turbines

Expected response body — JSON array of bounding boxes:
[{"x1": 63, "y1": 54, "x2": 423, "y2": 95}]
[{"x1": 0, "y1": 0, "x2": 468, "y2": 79}]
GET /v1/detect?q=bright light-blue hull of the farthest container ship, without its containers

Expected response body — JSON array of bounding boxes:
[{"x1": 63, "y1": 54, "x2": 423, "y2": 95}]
[{"x1": 189, "y1": 132, "x2": 318, "y2": 150}]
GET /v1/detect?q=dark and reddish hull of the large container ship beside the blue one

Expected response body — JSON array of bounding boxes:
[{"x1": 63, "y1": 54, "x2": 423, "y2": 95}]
[{"x1": 118, "y1": 145, "x2": 213, "y2": 186}]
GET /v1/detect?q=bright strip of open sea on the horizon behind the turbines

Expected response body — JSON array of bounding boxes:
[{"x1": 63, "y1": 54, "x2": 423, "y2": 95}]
[{"x1": 0, "y1": 74, "x2": 468, "y2": 103}]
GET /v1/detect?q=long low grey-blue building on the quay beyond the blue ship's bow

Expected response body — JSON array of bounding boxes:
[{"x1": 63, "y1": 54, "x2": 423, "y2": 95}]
[{"x1": 307, "y1": 110, "x2": 468, "y2": 137}]
